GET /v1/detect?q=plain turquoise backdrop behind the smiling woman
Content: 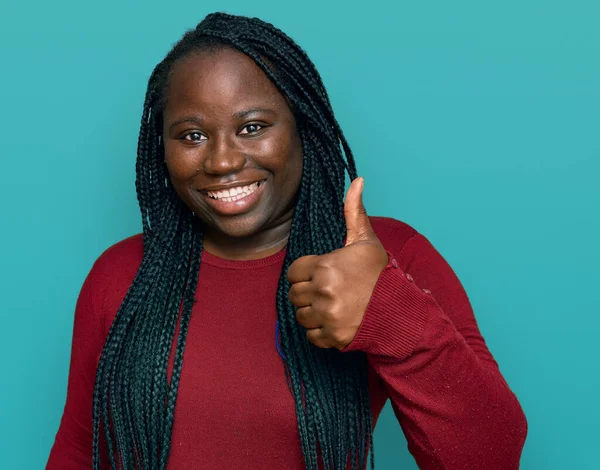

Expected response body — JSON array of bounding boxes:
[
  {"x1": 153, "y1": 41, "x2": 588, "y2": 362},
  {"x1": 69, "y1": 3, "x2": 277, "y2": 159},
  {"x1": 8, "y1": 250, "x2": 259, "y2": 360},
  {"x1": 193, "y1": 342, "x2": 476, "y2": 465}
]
[{"x1": 0, "y1": 0, "x2": 600, "y2": 470}]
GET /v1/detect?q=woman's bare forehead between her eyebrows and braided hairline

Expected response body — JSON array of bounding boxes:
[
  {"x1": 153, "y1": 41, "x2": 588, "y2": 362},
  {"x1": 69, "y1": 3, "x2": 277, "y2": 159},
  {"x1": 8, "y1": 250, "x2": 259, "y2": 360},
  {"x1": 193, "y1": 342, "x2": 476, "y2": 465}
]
[{"x1": 164, "y1": 48, "x2": 287, "y2": 117}]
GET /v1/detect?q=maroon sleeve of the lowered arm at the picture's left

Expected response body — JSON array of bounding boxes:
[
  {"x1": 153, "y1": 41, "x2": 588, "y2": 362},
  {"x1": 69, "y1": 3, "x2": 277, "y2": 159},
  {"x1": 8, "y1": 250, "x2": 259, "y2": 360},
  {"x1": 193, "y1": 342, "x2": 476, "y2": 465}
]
[{"x1": 46, "y1": 262, "x2": 105, "y2": 470}]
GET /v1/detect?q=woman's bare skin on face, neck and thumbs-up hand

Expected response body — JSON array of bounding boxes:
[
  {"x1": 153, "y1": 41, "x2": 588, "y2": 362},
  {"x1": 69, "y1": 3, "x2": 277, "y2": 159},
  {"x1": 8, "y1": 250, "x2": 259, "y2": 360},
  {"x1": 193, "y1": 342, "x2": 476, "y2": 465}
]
[{"x1": 163, "y1": 48, "x2": 389, "y2": 349}]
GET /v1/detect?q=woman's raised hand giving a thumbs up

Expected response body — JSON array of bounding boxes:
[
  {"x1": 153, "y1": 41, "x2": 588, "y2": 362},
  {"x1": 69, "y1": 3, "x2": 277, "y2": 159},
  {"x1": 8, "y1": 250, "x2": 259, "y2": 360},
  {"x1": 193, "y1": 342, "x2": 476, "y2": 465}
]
[{"x1": 287, "y1": 178, "x2": 388, "y2": 349}]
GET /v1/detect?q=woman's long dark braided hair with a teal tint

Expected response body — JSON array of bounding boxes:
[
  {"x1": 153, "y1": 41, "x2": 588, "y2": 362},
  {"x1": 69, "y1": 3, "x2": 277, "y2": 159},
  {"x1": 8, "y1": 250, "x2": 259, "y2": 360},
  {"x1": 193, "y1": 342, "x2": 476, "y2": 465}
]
[{"x1": 93, "y1": 13, "x2": 374, "y2": 470}]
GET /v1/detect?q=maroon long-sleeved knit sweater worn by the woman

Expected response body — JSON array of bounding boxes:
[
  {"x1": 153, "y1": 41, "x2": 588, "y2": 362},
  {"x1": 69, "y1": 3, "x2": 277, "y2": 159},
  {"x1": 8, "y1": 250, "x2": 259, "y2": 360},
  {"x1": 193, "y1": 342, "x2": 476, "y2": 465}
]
[{"x1": 47, "y1": 217, "x2": 527, "y2": 470}]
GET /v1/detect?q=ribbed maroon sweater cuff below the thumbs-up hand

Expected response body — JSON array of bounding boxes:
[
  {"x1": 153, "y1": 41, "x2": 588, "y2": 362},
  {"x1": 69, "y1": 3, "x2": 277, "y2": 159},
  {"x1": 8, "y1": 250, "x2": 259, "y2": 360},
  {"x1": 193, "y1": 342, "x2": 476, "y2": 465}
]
[{"x1": 342, "y1": 255, "x2": 435, "y2": 360}]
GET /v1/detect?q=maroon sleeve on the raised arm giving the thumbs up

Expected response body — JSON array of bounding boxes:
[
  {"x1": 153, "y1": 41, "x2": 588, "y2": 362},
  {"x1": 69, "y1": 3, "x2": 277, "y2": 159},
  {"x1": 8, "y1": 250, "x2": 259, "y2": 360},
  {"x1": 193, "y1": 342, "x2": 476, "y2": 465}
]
[{"x1": 345, "y1": 234, "x2": 527, "y2": 470}]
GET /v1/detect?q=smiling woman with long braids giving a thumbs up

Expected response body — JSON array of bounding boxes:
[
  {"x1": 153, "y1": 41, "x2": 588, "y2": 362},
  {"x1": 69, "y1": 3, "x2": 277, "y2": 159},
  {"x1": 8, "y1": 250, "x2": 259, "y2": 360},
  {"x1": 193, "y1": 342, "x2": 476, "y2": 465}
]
[{"x1": 48, "y1": 14, "x2": 526, "y2": 470}]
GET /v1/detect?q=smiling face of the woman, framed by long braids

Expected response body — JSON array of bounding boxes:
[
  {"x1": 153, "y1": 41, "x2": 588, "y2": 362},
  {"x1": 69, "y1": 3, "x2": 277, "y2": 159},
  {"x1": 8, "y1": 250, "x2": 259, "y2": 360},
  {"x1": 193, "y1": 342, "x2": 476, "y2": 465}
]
[{"x1": 163, "y1": 48, "x2": 302, "y2": 244}]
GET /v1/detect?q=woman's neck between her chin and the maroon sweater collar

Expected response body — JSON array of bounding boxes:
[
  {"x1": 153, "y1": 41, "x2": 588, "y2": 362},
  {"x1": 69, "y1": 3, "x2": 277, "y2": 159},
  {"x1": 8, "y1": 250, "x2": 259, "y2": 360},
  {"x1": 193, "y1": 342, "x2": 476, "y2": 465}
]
[{"x1": 204, "y1": 219, "x2": 292, "y2": 261}]
